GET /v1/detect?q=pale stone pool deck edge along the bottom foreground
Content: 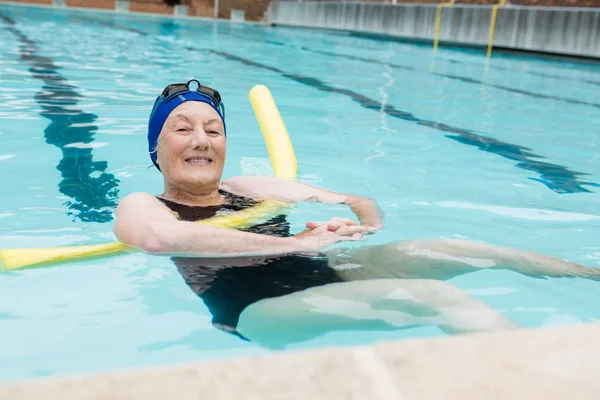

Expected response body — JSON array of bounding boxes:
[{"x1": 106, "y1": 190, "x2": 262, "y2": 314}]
[{"x1": 0, "y1": 324, "x2": 600, "y2": 400}]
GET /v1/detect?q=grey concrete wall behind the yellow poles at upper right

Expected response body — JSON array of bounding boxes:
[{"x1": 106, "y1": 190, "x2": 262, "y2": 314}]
[{"x1": 270, "y1": 1, "x2": 600, "y2": 58}]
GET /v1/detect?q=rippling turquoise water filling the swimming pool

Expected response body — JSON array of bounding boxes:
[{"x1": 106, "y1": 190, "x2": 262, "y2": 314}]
[{"x1": 0, "y1": 5, "x2": 600, "y2": 380}]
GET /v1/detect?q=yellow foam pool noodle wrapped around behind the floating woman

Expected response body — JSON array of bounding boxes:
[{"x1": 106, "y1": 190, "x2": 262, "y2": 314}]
[{"x1": 0, "y1": 85, "x2": 298, "y2": 271}]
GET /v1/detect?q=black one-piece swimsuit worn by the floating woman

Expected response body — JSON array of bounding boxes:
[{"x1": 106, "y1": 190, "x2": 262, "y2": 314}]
[{"x1": 159, "y1": 190, "x2": 341, "y2": 334}]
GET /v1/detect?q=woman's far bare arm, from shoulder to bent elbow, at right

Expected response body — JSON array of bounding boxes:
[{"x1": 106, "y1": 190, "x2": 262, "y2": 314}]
[{"x1": 221, "y1": 176, "x2": 384, "y2": 229}]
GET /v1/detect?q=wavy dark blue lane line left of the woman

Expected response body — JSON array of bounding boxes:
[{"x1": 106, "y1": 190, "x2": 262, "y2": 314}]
[{"x1": 0, "y1": 12, "x2": 119, "y2": 222}]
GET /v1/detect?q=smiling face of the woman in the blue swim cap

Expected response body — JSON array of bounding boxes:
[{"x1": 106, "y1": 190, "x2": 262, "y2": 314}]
[{"x1": 157, "y1": 101, "x2": 227, "y2": 191}]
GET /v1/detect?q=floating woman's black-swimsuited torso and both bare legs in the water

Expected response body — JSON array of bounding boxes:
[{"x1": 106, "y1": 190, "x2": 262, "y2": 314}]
[{"x1": 151, "y1": 185, "x2": 598, "y2": 348}]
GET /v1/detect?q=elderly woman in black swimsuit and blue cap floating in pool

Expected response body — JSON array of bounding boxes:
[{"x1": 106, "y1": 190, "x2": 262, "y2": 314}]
[{"x1": 115, "y1": 80, "x2": 598, "y2": 347}]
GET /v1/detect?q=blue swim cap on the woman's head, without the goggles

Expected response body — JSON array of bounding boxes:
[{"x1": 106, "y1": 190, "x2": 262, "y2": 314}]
[{"x1": 148, "y1": 90, "x2": 227, "y2": 171}]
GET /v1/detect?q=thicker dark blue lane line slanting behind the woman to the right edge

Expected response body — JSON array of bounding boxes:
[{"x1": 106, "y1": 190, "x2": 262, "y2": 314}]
[{"x1": 71, "y1": 20, "x2": 600, "y2": 194}]
